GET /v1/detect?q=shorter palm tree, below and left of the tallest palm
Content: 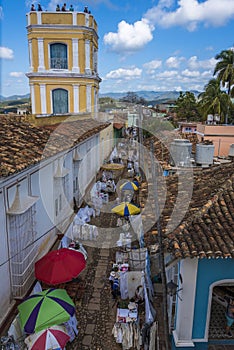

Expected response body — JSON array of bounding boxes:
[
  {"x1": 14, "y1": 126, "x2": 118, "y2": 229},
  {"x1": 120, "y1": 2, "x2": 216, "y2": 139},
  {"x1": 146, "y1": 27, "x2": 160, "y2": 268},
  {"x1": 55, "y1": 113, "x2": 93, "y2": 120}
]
[{"x1": 198, "y1": 79, "x2": 231, "y2": 121}]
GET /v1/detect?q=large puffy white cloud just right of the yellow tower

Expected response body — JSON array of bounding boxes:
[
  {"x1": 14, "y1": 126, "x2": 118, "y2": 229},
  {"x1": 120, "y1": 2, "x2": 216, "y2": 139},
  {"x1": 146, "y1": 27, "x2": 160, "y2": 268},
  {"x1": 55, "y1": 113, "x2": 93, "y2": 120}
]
[{"x1": 104, "y1": 19, "x2": 154, "y2": 53}]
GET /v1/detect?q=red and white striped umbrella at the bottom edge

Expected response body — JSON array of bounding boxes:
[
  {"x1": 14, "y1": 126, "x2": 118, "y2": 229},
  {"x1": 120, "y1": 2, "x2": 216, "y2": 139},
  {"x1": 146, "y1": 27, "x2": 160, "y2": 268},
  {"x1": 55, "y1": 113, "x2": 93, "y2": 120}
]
[{"x1": 25, "y1": 326, "x2": 70, "y2": 350}]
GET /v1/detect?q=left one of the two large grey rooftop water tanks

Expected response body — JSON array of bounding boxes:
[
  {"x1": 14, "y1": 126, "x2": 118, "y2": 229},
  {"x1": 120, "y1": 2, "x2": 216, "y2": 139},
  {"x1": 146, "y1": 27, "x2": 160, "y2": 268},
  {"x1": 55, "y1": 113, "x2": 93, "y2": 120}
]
[{"x1": 170, "y1": 139, "x2": 192, "y2": 167}]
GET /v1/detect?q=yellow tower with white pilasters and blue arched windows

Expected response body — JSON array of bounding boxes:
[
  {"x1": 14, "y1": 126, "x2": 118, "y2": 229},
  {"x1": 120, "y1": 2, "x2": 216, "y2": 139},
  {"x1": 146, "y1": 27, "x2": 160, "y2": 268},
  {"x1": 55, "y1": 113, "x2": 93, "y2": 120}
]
[{"x1": 26, "y1": 11, "x2": 101, "y2": 118}]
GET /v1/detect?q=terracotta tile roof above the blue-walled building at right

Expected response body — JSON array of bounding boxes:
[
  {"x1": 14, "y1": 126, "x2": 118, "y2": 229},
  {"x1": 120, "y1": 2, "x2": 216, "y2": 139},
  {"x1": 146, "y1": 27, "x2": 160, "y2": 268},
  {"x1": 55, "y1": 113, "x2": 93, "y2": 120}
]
[{"x1": 144, "y1": 135, "x2": 234, "y2": 258}]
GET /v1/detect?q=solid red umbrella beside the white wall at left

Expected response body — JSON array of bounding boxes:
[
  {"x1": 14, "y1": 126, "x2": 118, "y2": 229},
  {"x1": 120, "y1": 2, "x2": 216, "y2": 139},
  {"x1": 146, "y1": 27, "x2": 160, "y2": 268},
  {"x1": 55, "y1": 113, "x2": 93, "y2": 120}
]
[{"x1": 35, "y1": 248, "x2": 86, "y2": 285}]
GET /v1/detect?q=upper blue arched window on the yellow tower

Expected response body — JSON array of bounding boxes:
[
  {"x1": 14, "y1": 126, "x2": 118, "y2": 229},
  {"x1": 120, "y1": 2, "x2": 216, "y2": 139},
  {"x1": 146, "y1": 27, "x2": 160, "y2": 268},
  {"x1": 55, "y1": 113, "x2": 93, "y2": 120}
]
[{"x1": 50, "y1": 43, "x2": 68, "y2": 69}]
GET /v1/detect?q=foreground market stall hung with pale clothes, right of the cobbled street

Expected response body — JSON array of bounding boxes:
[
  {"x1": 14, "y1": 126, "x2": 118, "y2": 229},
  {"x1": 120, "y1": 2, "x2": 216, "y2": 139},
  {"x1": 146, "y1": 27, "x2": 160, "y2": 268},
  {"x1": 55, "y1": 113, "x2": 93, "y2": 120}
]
[{"x1": 110, "y1": 248, "x2": 156, "y2": 350}]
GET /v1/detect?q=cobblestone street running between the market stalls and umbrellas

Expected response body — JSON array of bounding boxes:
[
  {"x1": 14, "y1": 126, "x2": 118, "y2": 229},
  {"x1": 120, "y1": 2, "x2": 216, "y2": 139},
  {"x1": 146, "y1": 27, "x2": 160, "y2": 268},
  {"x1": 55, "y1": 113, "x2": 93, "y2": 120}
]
[{"x1": 61, "y1": 162, "x2": 168, "y2": 350}]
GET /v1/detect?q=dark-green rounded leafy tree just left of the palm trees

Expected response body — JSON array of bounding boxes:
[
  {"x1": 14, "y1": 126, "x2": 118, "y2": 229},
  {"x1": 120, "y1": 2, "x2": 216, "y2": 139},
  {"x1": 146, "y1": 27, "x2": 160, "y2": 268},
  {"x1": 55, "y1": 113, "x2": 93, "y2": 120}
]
[{"x1": 174, "y1": 91, "x2": 200, "y2": 121}]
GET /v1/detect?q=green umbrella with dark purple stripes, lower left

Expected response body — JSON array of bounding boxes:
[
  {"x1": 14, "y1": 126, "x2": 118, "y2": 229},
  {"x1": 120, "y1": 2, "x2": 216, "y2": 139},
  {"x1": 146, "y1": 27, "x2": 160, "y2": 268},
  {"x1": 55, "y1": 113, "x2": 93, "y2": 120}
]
[{"x1": 18, "y1": 288, "x2": 75, "y2": 334}]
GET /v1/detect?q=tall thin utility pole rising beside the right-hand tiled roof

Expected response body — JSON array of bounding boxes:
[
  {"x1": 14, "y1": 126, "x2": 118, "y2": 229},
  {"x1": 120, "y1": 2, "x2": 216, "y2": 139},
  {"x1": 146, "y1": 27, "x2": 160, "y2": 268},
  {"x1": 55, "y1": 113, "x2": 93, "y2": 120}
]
[{"x1": 150, "y1": 141, "x2": 171, "y2": 350}]
